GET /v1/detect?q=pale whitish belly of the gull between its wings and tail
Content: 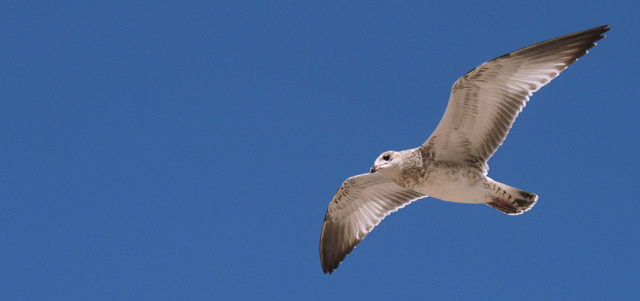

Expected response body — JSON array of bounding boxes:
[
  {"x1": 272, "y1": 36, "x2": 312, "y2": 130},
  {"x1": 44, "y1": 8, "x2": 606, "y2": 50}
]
[{"x1": 414, "y1": 170, "x2": 487, "y2": 203}]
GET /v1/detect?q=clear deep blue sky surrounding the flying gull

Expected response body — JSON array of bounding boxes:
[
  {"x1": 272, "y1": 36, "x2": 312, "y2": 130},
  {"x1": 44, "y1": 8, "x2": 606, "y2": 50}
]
[{"x1": 0, "y1": 1, "x2": 640, "y2": 300}]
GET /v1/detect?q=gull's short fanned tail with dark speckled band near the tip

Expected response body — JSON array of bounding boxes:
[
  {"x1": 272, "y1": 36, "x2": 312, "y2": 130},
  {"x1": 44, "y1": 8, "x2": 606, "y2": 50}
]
[{"x1": 487, "y1": 181, "x2": 538, "y2": 215}]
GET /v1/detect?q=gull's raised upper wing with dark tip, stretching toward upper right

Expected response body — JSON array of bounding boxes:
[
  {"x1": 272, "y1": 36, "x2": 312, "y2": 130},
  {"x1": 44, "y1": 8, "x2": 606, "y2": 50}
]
[{"x1": 422, "y1": 25, "x2": 609, "y2": 173}]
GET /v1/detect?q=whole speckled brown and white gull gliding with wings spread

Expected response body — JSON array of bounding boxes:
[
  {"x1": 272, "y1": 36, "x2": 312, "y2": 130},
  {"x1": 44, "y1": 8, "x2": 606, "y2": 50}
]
[{"x1": 320, "y1": 25, "x2": 610, "y2": 274}]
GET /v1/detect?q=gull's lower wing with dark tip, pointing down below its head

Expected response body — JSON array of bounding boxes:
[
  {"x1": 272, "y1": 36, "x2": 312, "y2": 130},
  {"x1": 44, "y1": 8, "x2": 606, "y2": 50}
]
[{"x1": 320, "y1": 172, "x2": 426, "y2": 274}]
